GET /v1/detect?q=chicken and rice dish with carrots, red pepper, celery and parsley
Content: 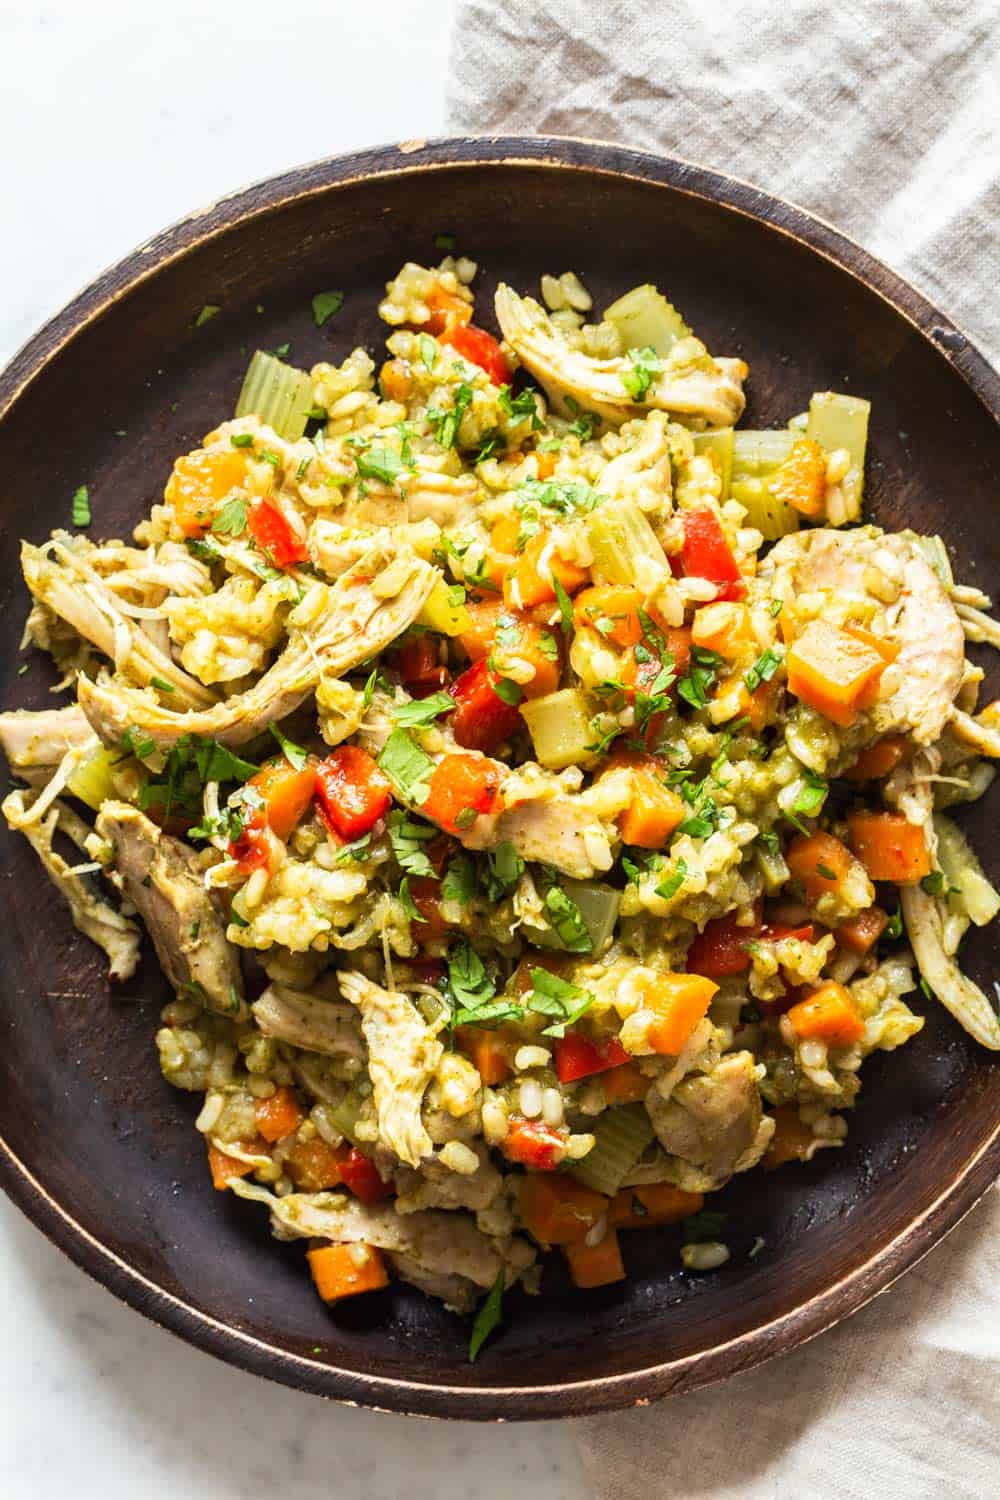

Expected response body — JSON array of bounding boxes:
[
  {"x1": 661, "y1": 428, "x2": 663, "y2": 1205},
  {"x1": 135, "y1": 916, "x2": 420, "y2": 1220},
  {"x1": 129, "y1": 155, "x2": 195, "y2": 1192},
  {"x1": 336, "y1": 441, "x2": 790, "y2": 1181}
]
[{"x1": 0, "y1": 255, "x2": 1000, "y2": 1358}]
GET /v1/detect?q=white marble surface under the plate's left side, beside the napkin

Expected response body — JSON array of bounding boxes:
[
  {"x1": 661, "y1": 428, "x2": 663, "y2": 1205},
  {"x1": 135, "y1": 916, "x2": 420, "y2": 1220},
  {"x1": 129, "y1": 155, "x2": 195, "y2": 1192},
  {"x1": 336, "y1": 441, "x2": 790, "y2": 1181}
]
[{"x1": 0, "y1": 0, "x2": 588, "y2": 1500}]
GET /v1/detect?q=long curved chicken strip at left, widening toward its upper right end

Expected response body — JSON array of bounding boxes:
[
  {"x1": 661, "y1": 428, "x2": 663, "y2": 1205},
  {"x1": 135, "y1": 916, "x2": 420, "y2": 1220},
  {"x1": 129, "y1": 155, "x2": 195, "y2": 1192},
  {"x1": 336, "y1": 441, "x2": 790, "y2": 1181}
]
[{"x1": 78, "y1": 548, "x2": 441, "y2": 750}]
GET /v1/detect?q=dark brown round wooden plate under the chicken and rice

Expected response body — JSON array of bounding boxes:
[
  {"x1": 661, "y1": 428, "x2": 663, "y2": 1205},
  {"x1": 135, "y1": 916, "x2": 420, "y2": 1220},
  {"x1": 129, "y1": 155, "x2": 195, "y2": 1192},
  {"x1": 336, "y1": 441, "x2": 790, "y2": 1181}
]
[{"x1": 0, "y1": 140, "x2": 1000, "y2": 1419}]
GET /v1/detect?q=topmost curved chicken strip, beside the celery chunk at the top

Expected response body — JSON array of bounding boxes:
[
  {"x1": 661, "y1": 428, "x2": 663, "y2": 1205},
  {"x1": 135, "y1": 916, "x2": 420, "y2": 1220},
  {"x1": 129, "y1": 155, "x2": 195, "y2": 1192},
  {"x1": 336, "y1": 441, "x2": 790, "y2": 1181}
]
[{"x1": 496, "y1": 284, "x2": 747, "y2": 428}]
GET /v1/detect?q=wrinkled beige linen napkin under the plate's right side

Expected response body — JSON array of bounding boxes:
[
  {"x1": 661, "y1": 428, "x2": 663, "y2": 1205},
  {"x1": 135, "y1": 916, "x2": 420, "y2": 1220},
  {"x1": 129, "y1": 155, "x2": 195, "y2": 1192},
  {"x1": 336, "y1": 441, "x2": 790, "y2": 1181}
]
[{"x1": 450, "y1": 0, "x2": 1000, "y2": 1500}]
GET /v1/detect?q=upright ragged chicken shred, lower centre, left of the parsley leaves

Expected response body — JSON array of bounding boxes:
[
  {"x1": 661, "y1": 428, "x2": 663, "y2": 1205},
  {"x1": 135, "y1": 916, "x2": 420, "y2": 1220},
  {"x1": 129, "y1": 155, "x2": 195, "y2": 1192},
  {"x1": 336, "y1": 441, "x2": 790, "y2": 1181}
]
[{"x1": 340, "y1": 971, "x2": 444, "y2": 1167}]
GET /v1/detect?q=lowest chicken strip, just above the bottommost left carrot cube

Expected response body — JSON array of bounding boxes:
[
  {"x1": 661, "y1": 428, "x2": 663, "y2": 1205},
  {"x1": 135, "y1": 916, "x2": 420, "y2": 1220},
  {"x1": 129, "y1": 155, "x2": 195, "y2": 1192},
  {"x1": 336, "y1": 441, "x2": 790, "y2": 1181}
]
[{"x1": 231, "y1": 1181, "x2": 535, "y2": 1313}]
